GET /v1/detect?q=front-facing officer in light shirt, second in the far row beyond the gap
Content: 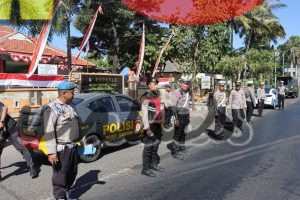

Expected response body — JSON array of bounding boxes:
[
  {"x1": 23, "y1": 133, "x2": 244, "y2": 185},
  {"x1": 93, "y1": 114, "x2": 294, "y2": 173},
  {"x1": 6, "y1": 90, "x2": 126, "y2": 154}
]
[{"x1": 228, "y1": 81, "x2": 247, "y2": 131}]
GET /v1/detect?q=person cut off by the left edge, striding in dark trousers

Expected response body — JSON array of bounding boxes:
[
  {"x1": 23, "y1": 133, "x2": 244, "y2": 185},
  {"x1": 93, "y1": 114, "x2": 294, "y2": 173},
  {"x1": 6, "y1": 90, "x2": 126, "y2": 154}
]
[{"x1": 0, "y1": 102, "x2": 38, "y2": 181}]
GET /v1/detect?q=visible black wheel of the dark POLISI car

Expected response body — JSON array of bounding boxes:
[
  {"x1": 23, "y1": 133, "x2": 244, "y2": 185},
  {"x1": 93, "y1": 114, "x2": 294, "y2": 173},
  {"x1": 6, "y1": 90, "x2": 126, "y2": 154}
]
[{"x1": 80, "y1": 135, "x2": 102, "y2": 163}]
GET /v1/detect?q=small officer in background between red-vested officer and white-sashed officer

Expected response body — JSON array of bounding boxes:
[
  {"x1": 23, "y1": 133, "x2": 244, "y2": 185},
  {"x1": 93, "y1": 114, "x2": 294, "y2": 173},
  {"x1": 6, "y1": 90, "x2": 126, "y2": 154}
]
[{"x1": 164, "y1": 83, "x2": 173, "y2": 129}]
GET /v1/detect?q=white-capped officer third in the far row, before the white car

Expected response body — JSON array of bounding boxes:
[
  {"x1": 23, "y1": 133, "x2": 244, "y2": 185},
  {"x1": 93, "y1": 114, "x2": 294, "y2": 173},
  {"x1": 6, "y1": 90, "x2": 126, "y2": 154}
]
[{"x1": 245, "y1": 81, "x2": 256, "y2": 124}]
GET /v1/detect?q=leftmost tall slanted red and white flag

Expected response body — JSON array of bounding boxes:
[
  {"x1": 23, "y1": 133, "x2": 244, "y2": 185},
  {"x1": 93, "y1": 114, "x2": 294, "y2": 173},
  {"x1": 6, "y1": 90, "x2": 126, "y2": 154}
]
[{"x1": 27, "y1": 0, "x2": 63, "y2": 77}]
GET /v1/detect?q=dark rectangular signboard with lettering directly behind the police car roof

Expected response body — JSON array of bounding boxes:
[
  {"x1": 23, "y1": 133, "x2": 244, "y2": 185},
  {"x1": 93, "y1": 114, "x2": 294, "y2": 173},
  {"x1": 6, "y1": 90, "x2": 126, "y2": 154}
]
[{"x1": 80, "y1": 73, "x2": 124, "y2": 94}]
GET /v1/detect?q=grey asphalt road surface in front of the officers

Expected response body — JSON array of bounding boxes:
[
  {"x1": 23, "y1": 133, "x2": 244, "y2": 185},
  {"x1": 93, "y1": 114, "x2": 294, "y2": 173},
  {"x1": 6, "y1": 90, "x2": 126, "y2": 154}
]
[{"x1": 0, "y1": 99, "x2": 300, "y2": 200}]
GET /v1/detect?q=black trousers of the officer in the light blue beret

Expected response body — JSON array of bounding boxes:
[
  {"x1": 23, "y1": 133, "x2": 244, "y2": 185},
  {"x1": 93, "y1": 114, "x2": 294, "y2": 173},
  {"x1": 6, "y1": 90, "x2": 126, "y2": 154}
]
[{"x1": 52, "y1": 147, "x2": 78, "y2": 199}]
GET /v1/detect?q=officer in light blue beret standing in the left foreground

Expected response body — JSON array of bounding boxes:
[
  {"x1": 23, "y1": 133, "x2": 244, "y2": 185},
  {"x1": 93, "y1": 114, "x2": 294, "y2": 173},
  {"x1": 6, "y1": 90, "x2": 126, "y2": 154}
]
[{"x1": 44, "y1": 82, "x2": 80, "y2": 199}]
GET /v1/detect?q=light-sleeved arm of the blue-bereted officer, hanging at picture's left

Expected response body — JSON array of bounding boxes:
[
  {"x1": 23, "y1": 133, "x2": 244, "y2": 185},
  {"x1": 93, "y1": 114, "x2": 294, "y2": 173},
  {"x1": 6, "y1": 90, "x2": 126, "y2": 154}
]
[{"x1": 44, "y1": 108, "x2": 57, "y2": 165}]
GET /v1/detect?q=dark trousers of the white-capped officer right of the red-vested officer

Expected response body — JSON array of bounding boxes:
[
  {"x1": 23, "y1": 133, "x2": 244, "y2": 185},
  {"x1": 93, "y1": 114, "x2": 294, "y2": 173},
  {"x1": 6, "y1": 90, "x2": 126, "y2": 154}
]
[{"x1": 173, "y1": 114, "x2": 190, "y2": 153}]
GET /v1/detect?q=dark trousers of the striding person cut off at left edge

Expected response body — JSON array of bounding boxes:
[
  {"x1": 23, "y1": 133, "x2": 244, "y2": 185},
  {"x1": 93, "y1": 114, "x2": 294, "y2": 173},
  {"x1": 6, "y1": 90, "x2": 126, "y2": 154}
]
[{"x1": 0, "y1": 125, "x2": 34, "y2": 175}]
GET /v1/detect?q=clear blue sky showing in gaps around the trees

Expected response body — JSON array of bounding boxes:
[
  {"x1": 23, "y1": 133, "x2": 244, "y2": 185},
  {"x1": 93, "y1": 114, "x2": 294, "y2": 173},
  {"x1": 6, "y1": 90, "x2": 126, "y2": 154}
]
[{"x1": 52, "y1": 0, "x2": 300, "y2": 56}]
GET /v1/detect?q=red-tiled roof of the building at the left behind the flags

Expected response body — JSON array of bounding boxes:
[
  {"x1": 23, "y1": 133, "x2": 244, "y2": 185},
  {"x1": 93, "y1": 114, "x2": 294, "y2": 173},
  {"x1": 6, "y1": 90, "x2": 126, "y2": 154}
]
[{"x1": 0, "y1": 26, "x2": 96, "y2": 67}]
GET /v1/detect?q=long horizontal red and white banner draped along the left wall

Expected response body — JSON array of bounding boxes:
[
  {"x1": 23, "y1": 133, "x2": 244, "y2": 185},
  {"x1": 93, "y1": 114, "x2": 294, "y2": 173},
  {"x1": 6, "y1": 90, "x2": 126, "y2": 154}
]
[{"x1": 0, "y1": 73, "x2": 65, "y2": 87}]
